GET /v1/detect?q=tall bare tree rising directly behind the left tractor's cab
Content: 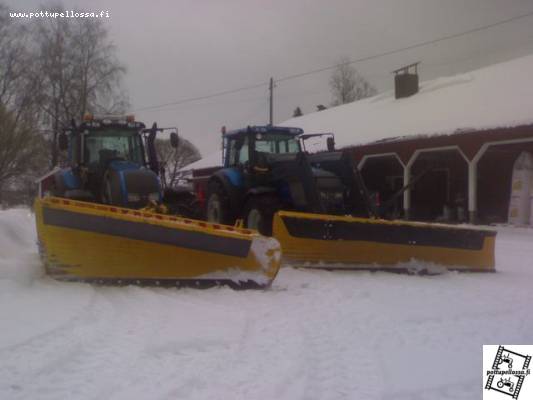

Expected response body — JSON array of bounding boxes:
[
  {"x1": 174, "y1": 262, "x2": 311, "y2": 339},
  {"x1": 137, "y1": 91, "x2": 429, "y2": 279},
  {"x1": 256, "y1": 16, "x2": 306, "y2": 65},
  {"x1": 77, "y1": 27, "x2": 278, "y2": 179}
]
[{"x1": 34, "y1": 4, "x2": 128, "y2": 165}]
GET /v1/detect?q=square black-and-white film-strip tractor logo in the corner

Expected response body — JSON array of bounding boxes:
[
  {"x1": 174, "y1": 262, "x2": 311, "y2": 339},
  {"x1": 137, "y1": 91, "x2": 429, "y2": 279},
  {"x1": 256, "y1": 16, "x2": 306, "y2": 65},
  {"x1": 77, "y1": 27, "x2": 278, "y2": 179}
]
[{"x1": 483, "y1": 345, "x2": 533, "y2": 400}]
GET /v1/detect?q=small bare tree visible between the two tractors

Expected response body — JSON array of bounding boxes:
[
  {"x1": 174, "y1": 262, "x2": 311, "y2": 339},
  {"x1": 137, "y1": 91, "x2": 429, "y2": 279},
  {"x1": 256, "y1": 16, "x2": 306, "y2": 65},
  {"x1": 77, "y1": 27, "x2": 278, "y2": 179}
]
[{"x1": 155, "y1": 137, "x2": 201, "y2": 187}]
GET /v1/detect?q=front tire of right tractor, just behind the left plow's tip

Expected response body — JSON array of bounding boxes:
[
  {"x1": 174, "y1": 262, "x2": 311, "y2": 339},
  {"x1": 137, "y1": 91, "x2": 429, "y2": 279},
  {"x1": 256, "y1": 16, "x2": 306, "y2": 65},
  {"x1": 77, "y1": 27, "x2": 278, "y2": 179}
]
[{"x1": 243, "y1": 195, "x2": 280, "y2": 236}]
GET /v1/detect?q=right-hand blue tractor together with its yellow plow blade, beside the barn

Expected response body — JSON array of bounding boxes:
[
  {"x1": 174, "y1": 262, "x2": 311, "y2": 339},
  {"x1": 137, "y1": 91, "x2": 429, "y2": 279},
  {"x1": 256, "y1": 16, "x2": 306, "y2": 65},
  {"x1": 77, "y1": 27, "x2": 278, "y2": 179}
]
[{"x1": 195, "y1": 126, "x2": 496, "y2": 271}]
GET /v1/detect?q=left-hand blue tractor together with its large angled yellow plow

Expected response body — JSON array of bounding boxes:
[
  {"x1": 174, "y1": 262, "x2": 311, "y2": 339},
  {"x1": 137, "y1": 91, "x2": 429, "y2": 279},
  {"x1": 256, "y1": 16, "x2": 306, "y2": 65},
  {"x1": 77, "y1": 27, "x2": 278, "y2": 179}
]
[{"x1": 35, "y1": 118, "x2": 281, "y2": 288}]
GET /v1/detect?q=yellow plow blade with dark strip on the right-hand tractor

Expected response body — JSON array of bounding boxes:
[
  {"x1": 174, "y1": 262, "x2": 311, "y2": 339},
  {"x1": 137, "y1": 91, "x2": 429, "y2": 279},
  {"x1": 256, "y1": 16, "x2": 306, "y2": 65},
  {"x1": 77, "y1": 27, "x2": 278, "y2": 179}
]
[{"x1": 273, "y1": 211, "x2": 496, "y2": 271}]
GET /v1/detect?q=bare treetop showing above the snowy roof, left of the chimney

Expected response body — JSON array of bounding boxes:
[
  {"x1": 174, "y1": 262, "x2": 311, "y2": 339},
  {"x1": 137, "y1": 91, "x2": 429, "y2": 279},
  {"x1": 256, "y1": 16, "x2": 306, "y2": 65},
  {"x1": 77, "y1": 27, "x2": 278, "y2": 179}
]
[{"x1": 329, "y1": 57, "x2": 377, "y2": 106}]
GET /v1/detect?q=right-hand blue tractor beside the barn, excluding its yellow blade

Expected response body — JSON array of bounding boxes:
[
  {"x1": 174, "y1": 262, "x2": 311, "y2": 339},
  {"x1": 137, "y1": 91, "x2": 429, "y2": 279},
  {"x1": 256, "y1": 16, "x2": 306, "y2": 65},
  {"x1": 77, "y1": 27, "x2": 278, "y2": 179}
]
[{"x1": 205, "y1": 126, "x2": 375, "y2": 235}]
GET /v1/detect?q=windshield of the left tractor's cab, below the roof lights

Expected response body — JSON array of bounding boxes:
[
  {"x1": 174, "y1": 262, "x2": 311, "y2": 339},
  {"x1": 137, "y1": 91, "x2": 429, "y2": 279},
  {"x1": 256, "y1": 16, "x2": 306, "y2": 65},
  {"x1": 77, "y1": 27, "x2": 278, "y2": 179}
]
[{"x1": 84, "y1": 130, "x2": 144, "y2": 165}]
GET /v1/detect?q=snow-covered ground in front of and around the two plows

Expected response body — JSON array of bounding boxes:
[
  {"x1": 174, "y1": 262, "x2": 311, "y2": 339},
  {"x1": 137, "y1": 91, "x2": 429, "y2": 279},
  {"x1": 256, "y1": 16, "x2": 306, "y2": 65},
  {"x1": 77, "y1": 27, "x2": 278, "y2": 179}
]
[{"x1": 0, "y1": 209, "x2": 533, "y2": 400}]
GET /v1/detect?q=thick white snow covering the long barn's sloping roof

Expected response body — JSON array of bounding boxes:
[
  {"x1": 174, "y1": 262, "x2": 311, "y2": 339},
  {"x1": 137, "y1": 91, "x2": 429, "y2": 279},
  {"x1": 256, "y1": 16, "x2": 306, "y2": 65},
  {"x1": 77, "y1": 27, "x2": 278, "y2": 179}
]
[{"x1": 280, "y1": 55, "x2": 533, "y2": 147}]
